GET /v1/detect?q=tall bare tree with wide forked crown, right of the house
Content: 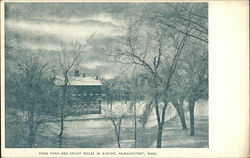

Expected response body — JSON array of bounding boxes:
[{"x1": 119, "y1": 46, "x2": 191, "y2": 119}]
[{"x1": 100, "y1": 3, "x2": 208, "y2": 147}]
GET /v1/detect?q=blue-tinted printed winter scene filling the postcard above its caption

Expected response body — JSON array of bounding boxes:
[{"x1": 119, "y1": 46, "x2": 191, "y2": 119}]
[{"x1": 4, "y1": 2, "x2": 209, "y2": 148}]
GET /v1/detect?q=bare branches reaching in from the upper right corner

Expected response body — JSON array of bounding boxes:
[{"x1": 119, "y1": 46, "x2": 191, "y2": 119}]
[{"x1": 151, "y1": 3, "x2": 208, "y2": 44}]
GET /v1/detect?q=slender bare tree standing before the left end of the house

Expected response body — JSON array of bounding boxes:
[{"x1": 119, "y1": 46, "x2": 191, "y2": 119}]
[{"x1": 58, "y1": 33, "x2": 95, "y2": 148}]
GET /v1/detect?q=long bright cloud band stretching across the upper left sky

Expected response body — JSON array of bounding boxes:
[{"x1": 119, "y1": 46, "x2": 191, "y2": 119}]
[{"x1": 6, "y1": 16, "x2": 124, "y2": 42}]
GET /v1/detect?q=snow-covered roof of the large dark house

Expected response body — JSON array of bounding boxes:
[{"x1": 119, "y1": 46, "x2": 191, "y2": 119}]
[{"x1": 55, "y1": 76, "x2": 102, "y2": 86}]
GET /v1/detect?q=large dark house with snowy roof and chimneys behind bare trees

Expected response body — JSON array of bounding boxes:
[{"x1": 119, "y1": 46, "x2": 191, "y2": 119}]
[{"x1": 55, "y1": 70, "x2": 102, "y2": 115}]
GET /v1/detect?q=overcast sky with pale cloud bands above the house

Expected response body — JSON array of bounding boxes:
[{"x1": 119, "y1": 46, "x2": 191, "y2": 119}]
[{"x1": 5, "y1": 3, "x2": 164, "y2": 78}]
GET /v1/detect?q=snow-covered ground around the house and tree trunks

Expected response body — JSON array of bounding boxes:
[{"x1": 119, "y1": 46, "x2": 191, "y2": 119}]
[{"x1": 36, "y1": 101, "x2": 208, "y2": 148}]
